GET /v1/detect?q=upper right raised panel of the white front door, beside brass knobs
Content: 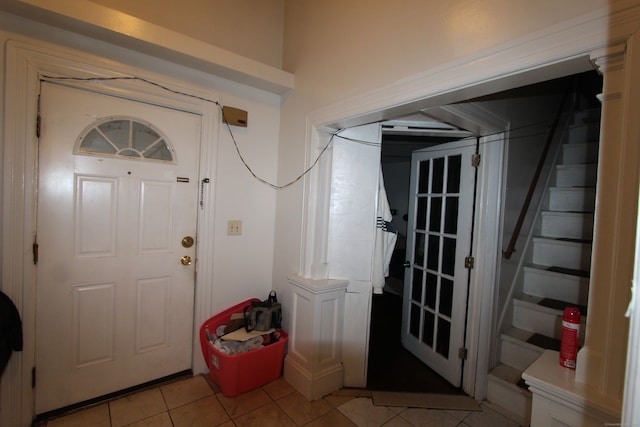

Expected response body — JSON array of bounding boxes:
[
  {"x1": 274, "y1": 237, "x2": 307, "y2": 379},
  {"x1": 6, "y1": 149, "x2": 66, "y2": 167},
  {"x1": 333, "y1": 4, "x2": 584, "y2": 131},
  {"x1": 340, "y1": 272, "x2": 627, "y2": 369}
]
[{"x1": 138, "y1": 181, "x2": 174, "y2": 253}]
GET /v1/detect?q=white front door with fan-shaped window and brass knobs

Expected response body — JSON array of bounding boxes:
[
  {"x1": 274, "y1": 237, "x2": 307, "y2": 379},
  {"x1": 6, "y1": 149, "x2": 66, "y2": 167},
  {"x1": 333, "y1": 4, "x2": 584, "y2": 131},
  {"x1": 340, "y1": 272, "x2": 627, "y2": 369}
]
[{"x1": 36, "y1": 82, "x2": 201, "y2": 413}]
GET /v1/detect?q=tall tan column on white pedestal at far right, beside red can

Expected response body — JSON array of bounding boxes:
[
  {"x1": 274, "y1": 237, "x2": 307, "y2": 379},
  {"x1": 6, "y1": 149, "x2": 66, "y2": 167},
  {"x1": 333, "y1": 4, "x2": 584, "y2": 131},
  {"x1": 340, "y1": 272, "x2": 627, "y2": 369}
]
[{"x1": 522, "y1": 30, "x2": 640, "y2": 427}]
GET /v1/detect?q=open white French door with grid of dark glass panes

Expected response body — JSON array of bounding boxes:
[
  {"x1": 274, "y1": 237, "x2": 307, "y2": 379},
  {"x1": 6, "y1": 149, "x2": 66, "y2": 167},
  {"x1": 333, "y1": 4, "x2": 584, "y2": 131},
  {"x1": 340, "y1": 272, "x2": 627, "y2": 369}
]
[{"x1": 402, "y1": 139, "x2": 475, "y2": 387}]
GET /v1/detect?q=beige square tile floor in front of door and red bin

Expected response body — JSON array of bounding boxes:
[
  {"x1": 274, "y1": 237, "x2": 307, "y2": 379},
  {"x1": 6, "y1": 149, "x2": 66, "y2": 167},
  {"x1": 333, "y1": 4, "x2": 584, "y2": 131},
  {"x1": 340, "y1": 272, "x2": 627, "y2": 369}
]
[{"x1": 46, "y1": 376, "x2": 518, "y2": 427}]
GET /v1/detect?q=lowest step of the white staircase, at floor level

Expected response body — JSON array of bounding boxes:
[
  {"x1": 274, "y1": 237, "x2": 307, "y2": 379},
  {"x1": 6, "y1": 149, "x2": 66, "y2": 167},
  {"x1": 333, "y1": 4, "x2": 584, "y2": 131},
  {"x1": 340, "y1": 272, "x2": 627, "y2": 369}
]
[{"x1": 487, "y1": 364, "x2": 531, "y2": 420}]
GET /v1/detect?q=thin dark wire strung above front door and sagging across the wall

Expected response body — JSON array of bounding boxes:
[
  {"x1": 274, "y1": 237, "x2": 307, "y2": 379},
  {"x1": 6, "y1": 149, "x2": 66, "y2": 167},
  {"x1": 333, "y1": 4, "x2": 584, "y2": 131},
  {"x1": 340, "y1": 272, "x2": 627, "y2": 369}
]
[{"x1": 40, "y1": 74, "x2": 564, "y2": 190}]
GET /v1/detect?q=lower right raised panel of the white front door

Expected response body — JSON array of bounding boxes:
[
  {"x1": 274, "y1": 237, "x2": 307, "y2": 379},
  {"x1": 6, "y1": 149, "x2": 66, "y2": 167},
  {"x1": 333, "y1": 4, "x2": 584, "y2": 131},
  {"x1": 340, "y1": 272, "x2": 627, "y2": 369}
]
[{"x1": 136, "y1": 277, "x2": 171, "y2": 353}]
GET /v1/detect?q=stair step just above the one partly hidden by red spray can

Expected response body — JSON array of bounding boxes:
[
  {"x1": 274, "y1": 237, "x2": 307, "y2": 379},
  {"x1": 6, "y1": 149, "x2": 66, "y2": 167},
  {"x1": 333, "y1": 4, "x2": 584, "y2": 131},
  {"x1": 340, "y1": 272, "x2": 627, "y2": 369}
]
[{"x1": 523, "y1": 265, "x2": 589, "y2": 305}]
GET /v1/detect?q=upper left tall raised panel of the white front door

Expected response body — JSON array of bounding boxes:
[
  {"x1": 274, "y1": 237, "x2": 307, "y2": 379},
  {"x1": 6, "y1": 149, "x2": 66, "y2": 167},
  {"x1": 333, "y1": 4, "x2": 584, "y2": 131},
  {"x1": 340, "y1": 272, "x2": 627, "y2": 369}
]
[{"x1": 75, "y1": 175, "x2": 117, "y2": 257}]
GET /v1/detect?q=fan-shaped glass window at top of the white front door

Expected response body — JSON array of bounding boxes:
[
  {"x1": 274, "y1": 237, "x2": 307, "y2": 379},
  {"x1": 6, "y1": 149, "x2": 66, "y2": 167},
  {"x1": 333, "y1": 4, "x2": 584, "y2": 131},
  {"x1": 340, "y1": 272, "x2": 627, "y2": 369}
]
[{"x1": 75, "y1": 117, "x2": 175, "y2": 163}]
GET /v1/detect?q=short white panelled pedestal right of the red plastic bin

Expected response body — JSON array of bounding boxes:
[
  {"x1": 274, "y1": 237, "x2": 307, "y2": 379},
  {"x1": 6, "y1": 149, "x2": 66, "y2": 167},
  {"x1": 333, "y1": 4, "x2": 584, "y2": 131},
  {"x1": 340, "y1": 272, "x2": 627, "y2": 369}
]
[{"x1": 284, "y1": 276, "x2": 348, "y2": 400}]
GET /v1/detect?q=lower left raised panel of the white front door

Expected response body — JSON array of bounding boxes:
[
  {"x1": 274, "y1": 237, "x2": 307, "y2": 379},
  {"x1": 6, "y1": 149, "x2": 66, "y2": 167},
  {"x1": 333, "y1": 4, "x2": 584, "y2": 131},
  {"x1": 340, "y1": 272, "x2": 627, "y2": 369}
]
[{"x1": 72, "y1": 283, "x2": 115, "y2": 368}]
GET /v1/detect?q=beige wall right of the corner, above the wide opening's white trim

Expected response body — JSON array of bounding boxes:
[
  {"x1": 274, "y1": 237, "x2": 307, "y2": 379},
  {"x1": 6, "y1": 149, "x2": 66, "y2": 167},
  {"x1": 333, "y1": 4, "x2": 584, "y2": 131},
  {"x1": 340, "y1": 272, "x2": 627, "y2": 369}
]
[{"x1": 274, "y1": 0, "x2": 608, "y2": 300}]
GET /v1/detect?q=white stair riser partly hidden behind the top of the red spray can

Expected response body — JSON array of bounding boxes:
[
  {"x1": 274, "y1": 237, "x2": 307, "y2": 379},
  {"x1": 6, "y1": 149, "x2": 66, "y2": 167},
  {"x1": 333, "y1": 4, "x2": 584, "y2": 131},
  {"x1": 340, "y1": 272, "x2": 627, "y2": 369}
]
[{"x1": 513, "y1": 300, "x2": 585, "y2": 345}]
